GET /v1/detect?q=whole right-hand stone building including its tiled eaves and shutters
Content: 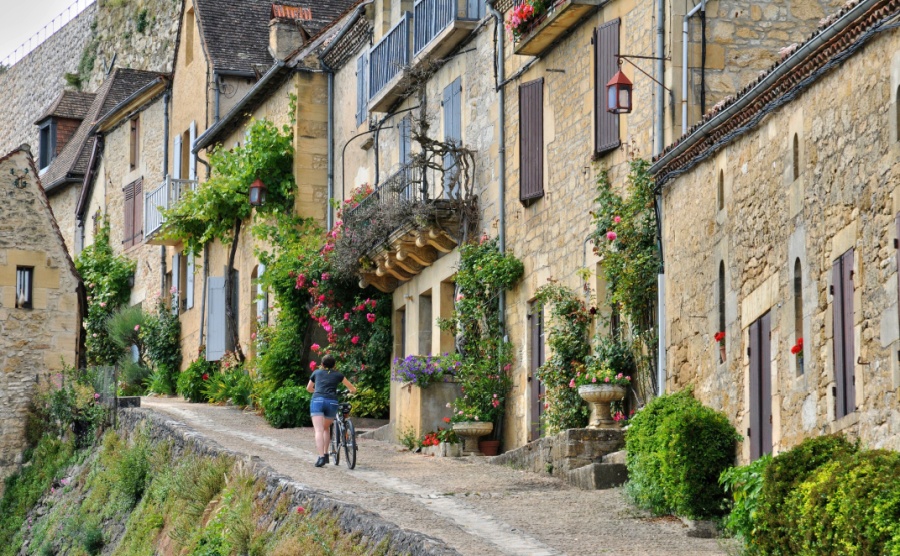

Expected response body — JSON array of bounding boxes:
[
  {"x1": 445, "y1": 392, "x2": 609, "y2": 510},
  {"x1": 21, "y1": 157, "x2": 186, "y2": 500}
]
[{"x1": 652, "y1": 0, "x2": 900, "y2": 462}]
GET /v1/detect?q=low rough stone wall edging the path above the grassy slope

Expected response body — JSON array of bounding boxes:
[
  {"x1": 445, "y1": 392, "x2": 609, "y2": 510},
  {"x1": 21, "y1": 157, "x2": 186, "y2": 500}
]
[{"x1": 118, "y1": 409, "x2": 458, "y2": 556}]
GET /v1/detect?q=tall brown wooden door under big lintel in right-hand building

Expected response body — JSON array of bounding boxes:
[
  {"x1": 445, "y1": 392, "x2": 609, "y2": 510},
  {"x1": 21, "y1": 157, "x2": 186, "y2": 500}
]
[{"x1": 747, "y1": 313, "x2": 772, "y2": 461}]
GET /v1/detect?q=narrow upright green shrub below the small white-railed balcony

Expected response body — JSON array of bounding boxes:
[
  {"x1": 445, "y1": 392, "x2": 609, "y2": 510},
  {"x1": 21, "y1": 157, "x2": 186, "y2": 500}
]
[{"x1": 141, "y1": 298, "x2": 181, "y2": 395}]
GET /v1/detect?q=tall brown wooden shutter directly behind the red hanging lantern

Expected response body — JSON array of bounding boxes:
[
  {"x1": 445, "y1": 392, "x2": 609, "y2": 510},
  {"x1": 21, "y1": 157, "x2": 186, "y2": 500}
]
[{"x1": 593, "y1": 19, "x2": 621, "y2": 155}]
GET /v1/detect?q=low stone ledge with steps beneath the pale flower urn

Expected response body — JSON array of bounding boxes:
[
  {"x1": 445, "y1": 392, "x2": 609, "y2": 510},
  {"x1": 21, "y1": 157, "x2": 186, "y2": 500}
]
[{"x1": 489, "y1": 429, "x2": 625, "y2": 478}]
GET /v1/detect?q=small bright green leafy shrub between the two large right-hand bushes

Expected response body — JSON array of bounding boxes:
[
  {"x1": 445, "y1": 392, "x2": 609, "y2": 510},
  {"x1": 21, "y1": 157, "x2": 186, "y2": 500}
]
[{"x1": 719, "y1": 454, "x2": 772, "y2": 542}]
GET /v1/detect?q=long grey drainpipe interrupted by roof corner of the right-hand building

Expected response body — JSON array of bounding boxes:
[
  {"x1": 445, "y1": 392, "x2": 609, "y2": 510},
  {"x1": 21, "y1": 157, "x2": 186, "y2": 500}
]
[{"x1": 653, "y1": 0, "x2": 666, "y2": 395}]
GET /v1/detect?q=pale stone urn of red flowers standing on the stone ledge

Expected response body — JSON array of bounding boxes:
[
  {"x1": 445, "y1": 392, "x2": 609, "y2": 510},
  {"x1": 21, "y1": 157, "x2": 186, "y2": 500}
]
[{"x1": 569, "y1": 357, "x2": 631, "y2": 429}]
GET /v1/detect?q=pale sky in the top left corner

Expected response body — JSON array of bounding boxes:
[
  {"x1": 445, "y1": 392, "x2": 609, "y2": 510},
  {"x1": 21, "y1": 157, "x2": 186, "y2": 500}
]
[{"x1": 0, "y1": 0, "x2": 94, "y2": 65}]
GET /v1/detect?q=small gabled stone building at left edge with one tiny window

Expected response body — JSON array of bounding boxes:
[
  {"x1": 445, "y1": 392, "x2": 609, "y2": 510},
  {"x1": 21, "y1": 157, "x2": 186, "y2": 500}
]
[{"x1": 0, "y1": 145, "x2": 84, "y2": 488}]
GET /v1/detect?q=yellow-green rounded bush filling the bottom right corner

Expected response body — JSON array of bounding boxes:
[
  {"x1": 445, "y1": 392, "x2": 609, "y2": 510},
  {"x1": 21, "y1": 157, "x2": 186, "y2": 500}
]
[{"x1": 784, "y1": 450, "x2": 900, "y2": 556}]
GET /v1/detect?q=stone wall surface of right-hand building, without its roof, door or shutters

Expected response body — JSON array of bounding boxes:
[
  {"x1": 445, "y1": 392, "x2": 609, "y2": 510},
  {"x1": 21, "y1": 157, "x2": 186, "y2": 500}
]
[{"x1": 663, "y1": 6, "x2": 900, "y2": 462}]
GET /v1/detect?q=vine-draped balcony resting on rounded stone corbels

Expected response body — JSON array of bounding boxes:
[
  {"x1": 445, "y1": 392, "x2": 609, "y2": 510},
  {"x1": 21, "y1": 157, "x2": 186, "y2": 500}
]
[{"x1": 345, "y1": 164, "x2": 460, "y2": 293}]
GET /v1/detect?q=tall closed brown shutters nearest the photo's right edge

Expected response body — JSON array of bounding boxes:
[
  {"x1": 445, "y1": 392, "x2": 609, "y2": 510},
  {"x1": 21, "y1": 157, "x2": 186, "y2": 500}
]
[{"x1": 831, "y1": 249, "x2": 856, "y2": 419}]
